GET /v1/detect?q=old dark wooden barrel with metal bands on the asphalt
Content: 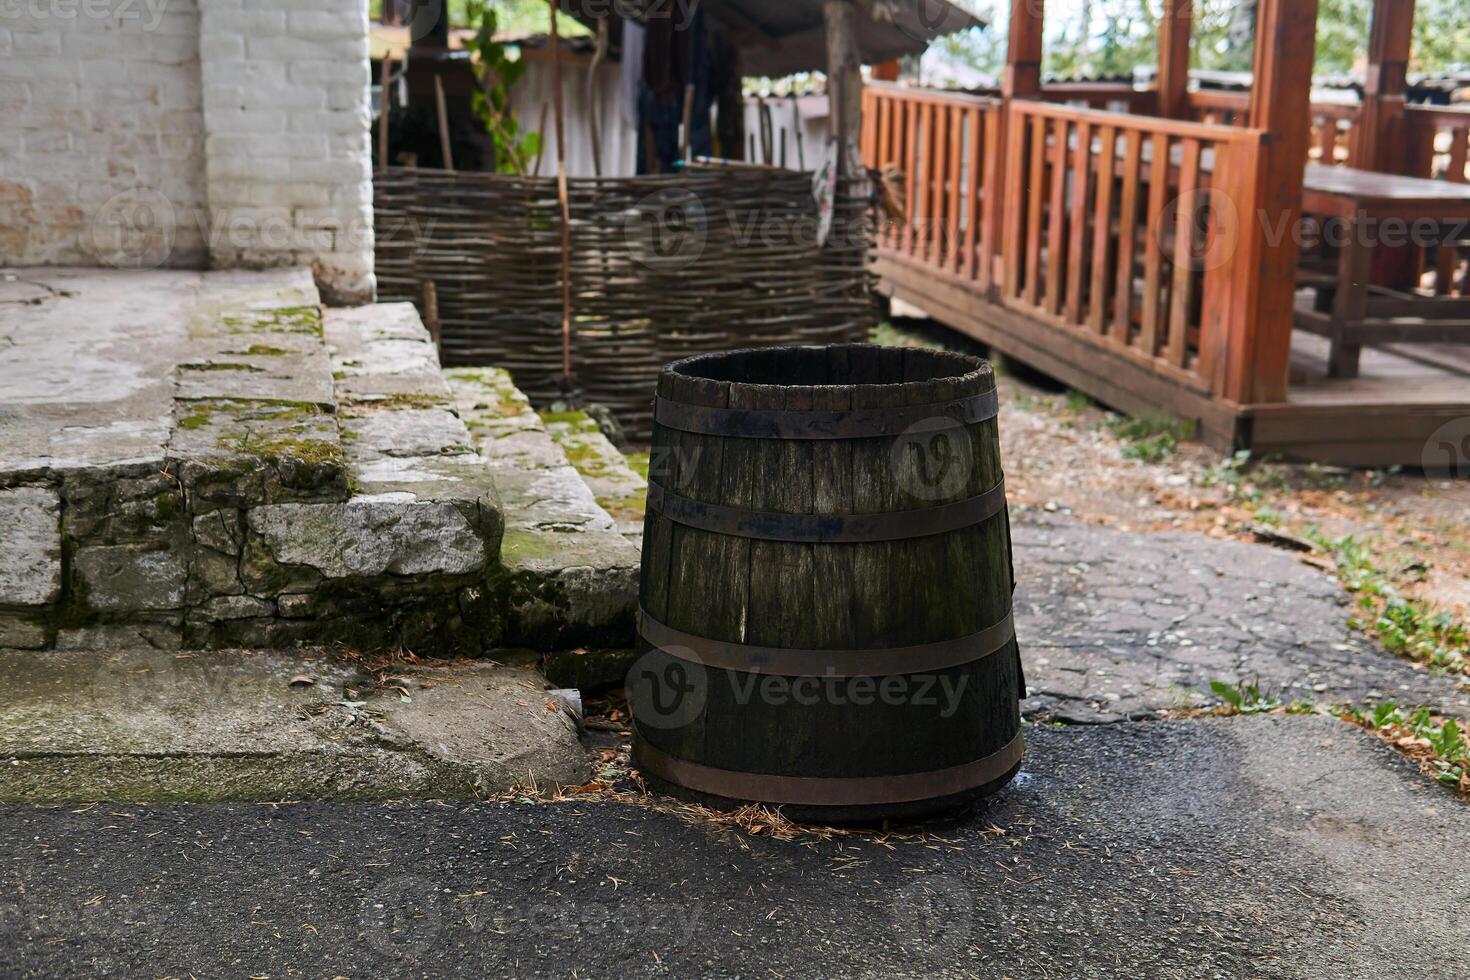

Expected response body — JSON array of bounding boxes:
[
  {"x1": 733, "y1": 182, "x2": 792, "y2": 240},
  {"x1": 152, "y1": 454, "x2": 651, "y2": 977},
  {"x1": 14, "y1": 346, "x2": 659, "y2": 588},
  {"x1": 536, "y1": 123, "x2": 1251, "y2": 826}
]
[{"x1": 628, "y1": 345, "x2": 1025, "y2": 820}]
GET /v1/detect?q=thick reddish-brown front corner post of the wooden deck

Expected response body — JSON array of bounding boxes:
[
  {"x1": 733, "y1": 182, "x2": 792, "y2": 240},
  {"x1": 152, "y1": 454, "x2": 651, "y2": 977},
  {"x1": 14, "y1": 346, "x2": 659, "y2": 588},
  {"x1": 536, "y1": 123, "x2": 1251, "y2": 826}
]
[{"x1": 1223, "y1": 0, "x2": 1317, "y2": 404}]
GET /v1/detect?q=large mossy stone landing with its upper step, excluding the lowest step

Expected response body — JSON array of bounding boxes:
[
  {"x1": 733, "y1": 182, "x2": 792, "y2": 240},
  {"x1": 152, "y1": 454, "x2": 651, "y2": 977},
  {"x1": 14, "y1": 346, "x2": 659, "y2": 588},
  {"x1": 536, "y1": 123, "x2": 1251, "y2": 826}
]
[{"x1": 0, "y1": 270, "x2": 504, "y2": 654}]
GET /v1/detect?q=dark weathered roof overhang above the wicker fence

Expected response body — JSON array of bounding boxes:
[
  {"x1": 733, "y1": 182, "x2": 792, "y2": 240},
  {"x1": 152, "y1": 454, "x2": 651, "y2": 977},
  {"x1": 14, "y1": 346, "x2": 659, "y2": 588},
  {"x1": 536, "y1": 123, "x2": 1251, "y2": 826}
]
[{"x1": 566, "y1": 0, "x2": 985, "y2": 76}]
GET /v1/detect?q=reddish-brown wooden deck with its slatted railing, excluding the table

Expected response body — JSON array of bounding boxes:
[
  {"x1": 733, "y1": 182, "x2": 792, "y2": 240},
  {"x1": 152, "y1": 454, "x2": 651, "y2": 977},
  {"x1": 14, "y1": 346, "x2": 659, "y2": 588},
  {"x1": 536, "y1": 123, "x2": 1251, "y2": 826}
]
[{"x1": 863, "y1": 73, "x2": 1470, "y2": 466}]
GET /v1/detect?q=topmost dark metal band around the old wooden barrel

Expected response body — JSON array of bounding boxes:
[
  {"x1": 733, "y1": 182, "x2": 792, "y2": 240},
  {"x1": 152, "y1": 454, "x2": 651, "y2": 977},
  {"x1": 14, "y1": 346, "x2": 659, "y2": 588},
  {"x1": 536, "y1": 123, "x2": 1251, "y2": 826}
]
[{"x1": 653, "y1": 389, "x2": 1000, "y2": 439}]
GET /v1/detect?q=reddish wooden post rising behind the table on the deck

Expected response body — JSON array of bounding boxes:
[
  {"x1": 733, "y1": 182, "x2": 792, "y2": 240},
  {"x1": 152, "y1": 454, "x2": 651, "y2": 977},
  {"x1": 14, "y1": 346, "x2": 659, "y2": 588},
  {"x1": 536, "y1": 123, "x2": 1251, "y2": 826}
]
[{"x1": 1352, "y1": 0, "x2": 1414, "y2": 173}]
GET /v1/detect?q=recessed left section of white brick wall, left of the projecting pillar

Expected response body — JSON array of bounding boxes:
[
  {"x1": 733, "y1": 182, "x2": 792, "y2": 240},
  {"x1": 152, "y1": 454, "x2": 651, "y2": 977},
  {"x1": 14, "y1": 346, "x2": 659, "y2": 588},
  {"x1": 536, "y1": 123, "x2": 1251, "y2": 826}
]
[{"x1": 0, "y1": 0, "x2": 207, "y2": 266}]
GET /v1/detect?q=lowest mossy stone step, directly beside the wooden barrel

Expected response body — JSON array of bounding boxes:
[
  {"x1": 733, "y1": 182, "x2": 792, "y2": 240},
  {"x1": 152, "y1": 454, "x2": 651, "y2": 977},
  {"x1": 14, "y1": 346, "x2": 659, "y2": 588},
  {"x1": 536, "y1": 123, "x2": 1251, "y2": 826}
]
[{"x1": 445, "y1": 367, "x2": 638, "y2": 649}]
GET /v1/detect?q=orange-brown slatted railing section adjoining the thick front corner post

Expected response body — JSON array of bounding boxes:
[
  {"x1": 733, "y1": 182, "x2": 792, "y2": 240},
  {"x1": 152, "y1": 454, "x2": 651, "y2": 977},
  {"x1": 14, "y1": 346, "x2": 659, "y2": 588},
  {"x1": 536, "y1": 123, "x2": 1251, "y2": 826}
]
[{"x1": 1000, "y1": 100, "x2": 1263, "y2": 394}]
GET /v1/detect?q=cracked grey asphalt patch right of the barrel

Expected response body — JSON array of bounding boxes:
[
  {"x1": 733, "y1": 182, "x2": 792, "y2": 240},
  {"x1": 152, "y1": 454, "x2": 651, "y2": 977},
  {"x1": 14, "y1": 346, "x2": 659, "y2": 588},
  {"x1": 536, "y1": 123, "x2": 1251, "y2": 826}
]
[{"x1": 1013, "y1": 510, "x2": 1470, "y2": 724}]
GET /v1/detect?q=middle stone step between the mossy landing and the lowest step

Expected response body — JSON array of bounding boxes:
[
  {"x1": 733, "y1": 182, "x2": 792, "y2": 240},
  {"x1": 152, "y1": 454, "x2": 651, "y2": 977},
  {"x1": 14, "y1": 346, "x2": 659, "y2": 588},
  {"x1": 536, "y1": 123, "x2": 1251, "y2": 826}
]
[{"x1": 204, "y1": 303, "x2": 503, "y2": 655}]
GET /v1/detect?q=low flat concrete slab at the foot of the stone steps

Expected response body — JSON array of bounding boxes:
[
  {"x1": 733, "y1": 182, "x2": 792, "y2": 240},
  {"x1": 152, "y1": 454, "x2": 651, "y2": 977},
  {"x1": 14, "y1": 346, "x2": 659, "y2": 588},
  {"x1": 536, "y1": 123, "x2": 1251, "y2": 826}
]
[{"x1": 0, "y1": 646, "x2": 587, "y2": 802}]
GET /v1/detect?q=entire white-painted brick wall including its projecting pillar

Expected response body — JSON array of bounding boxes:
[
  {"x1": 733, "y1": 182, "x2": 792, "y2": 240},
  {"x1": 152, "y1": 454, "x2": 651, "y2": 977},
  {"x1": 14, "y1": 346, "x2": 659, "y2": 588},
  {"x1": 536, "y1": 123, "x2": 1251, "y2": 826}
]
[{"x1": 0, "y1": 0, "x2": 375, "y2": 303}]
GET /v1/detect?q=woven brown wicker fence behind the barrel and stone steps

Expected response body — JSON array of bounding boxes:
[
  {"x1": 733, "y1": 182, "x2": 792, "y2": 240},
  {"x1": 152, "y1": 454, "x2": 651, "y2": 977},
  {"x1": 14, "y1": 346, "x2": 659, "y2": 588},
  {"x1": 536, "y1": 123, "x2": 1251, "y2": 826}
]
[{"x1": 373, "y1": 167, "x2": 875, "y2": 438}]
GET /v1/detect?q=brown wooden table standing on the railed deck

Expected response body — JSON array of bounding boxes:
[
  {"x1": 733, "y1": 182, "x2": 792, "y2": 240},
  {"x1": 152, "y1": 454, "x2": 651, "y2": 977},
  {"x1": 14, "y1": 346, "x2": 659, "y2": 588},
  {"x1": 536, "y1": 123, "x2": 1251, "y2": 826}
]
[{"x1": 1297, "y1": 163, "x2": 1470, "y2": 378}]
